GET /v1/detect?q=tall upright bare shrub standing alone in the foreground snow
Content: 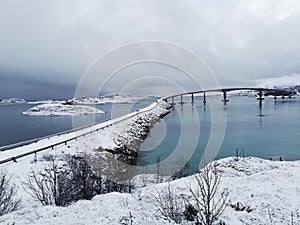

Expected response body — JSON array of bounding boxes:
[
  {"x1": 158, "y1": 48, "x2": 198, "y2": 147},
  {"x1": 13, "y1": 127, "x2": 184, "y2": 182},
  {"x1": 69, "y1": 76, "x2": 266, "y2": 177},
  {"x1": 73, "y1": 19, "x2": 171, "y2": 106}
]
[{"x1": 188, "y1": 162, "x2": 229, "y2": 225}]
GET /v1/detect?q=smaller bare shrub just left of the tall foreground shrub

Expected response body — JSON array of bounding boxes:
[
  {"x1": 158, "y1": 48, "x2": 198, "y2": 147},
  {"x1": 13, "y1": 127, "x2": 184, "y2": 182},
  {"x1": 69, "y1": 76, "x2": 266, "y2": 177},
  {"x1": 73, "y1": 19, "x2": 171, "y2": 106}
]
[{"x1": 154, "y1": 184, "x2": 183, "y2": 223}]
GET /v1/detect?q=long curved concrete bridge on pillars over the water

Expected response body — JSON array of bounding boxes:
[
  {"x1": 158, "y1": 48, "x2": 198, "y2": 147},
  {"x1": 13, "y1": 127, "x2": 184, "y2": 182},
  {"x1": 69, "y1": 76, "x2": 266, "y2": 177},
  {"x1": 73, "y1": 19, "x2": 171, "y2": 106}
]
[{"x1": 163, "y1": 87, "x2": 296, "y2": 106}]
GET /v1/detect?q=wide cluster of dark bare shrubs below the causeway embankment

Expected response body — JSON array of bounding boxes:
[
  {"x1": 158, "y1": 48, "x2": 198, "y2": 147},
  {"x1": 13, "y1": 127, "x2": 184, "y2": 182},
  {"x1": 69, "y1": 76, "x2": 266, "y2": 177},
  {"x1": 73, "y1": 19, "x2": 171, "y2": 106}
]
[{"x1": 23, "y1": 155, "x2": 134, "y2": 206}]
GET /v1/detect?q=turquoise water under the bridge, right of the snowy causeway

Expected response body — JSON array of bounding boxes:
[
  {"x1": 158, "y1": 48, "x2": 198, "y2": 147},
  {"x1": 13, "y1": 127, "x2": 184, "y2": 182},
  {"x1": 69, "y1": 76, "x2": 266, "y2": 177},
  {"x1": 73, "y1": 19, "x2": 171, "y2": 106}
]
[{"x1": 140, "y1": 96, "x2": 300, "y2": 172}]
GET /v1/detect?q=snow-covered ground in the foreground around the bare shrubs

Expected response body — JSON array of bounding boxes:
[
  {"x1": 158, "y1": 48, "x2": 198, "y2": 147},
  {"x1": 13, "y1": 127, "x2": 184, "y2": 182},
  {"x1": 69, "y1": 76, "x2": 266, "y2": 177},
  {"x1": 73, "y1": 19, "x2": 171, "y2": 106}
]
[{"x1": 0, "y1": 158, "x2": 300, "y2": 225}]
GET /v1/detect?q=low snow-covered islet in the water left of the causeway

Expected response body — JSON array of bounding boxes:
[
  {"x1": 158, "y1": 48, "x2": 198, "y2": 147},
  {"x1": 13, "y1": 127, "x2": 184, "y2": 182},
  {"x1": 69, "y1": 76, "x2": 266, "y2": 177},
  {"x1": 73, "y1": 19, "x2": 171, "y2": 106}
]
[{"x1": 23, "y1": 103, "x2": 104, "y2": 116}]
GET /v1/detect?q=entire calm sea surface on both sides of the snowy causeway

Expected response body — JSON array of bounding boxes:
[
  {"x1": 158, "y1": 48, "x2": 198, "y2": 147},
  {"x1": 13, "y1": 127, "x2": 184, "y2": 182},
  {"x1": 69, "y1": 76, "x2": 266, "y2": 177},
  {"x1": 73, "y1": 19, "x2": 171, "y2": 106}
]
[{"x1": 0, "y1": 96, "x2": 300, "y2": 171}]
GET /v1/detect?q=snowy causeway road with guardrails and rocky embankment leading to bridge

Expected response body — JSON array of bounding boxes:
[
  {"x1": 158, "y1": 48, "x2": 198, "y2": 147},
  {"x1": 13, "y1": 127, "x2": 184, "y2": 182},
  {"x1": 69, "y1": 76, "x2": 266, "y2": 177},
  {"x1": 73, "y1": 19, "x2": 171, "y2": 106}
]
[{"x1": 0, "y1": 100, "x2": 170, "y2": 164}]
